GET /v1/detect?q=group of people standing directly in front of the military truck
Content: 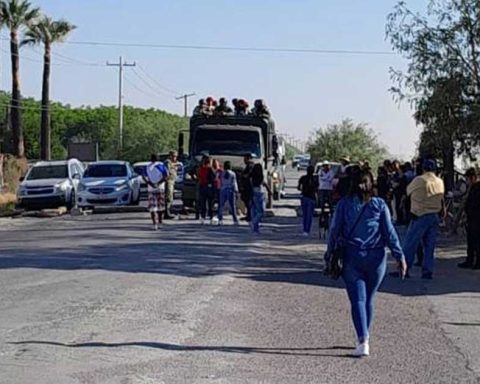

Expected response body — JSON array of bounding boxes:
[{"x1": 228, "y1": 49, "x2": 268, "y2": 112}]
[{"x1": 196, "y1": 155, "x2": 271, "y2": 233}]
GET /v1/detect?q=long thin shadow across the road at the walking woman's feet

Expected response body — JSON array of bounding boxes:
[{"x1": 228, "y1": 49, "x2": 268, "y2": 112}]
[{"x1": 8, "y1": 340, "x2": 355, "y2": 358}]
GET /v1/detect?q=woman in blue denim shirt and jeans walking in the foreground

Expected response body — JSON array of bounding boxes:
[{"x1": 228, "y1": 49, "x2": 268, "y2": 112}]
[{"x1": 327, "y1": 169, "x2": 407, "y2": 357}]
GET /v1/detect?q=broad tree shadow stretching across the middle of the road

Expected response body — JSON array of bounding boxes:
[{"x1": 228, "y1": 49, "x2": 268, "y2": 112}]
[{"x1": 0, "y1": 213, "x2": 480, "y2": 299}]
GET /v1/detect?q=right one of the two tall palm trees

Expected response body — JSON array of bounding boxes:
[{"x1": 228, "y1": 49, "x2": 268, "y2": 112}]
[{"x1": 22, "y1": 16, "x2": 76, "y2": 160}]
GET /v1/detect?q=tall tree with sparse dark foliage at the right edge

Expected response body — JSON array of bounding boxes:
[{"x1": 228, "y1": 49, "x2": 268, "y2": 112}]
[{"x1": 387, "y1": 0, "x2": 480, "y2": 189}]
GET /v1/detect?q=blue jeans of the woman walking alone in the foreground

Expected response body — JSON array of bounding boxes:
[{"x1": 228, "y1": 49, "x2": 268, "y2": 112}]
[{"x1": 342, "y1": 247, "x2": 387, "y2": 343}]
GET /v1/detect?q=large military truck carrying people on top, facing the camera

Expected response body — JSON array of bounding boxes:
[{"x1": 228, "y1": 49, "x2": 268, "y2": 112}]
[{"x1": 179, "y1": 110, "x2": 280, "y2": 207}]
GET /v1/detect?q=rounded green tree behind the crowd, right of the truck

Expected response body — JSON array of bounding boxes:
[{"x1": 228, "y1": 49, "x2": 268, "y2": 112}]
[{"x1": 308, "y1": 119, "x2": 388, "y2": 169}]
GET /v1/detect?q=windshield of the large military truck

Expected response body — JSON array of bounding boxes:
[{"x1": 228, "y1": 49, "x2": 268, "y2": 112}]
[{"x1": 194, "y1": 128, "x2": 262, "y2": 158}]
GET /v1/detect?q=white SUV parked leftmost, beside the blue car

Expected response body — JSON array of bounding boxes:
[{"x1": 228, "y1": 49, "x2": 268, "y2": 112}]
[{"x1": 17, "y1": 159, "x2": 84, "y2": 209}]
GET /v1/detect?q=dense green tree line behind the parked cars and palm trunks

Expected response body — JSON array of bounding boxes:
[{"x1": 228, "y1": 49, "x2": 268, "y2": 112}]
[{"x1": 0, "y1": 92, "x2": 188, "y2": 162}]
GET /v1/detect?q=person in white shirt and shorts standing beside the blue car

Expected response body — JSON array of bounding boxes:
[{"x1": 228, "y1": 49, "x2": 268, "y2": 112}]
[{"x1": 142, "y1": 155, "x2": 168, "y2": 231}]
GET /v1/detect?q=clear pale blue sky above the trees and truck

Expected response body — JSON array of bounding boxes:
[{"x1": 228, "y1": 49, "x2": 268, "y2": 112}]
[{"x1": 1, "y1": 0, "x2": 424, "y2": 156}]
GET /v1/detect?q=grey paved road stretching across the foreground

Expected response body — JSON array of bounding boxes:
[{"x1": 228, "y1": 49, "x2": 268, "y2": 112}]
[{"x1": 0, "y1": 170, "x2": 480, "y2": 384}]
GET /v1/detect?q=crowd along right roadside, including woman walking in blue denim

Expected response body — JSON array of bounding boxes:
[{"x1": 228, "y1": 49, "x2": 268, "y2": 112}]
[{"x1": 298, "y1": 154, "x2": 468, "y2": 356}]
